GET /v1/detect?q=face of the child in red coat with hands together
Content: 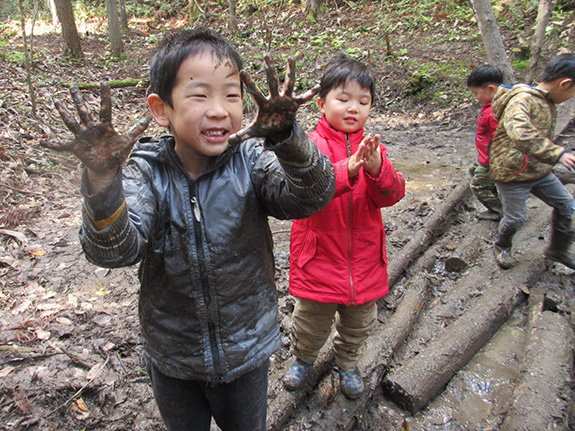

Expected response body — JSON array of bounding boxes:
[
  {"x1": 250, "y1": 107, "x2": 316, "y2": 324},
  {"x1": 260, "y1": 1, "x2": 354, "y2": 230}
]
[{"x1": 317, "y1": 80, "x2": 371, "y2": 133}]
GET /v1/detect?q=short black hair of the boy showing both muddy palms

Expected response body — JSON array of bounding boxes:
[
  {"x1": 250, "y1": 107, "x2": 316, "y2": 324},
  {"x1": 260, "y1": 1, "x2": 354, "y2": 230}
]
[{"x1": 150, "y1": 28, "x2": 243, "y2": 107}]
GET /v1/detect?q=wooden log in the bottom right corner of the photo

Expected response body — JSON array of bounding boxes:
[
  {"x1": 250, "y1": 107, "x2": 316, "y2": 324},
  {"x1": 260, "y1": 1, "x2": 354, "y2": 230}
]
[{"x1": 500, "y1": 311, "x2": 575, "y2": 431}]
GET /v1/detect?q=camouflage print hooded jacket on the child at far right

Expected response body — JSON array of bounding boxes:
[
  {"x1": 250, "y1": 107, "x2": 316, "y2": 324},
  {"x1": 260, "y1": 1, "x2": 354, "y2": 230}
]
[{"x1": 489, "y1": 84, "x2": 565, "y2": 182}]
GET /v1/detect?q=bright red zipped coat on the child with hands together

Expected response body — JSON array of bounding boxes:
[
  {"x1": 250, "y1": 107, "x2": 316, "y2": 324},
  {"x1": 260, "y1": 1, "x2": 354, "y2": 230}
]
[{"x1": 289, "y1": 117, "x2": 405, "y2": 305}]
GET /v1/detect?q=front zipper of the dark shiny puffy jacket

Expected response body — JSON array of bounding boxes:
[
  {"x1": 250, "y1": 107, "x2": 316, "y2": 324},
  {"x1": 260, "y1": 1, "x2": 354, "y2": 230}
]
[{"x1": 191, "y1": 186, "x2": 221, "y2": 374}]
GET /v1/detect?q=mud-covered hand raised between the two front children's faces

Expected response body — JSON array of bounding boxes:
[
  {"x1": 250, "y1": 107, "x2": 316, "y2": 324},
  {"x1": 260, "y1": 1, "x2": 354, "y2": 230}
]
[{"x1": 229, "y1": 54, "x2": 319, "y2": 145}]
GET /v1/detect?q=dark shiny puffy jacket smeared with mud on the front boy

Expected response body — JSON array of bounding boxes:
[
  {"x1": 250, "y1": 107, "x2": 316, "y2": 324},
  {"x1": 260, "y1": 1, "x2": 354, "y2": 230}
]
[{"x1": 80, "y1": 126, "x2": 335, "y2": 383}]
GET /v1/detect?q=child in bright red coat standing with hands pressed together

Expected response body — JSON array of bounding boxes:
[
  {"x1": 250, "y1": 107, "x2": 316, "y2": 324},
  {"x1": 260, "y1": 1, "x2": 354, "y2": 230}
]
[{"x1": 284, "y1": 54, "x2": 405, "y2": 398}]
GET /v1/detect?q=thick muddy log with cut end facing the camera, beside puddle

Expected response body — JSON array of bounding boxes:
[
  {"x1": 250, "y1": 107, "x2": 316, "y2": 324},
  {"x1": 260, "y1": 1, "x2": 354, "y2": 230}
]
[{"x1": 383, "y1": 261, "x2": 542, "y2": 414}]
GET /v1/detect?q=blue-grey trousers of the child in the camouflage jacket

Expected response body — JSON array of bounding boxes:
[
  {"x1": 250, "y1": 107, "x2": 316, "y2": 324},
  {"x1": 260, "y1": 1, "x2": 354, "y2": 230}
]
[{"x1": 497, "y1": 174, "x2": 575, "y2": 246}]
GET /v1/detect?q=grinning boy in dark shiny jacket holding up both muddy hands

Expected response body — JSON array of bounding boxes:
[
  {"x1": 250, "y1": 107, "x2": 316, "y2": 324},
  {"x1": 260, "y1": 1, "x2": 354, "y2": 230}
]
[{"x1": 42, "y1": 29, "x2": 335, "y2": 431}]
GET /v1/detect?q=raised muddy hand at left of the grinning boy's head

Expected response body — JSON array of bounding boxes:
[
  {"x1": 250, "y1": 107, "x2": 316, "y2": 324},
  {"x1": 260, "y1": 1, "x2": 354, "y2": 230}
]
[{"x1": 40, "y1": 83, "x2": 150, "y2": 174}]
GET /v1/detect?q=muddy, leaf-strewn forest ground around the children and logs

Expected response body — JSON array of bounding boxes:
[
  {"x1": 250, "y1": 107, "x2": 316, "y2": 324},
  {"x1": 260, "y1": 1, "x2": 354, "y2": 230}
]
[{"x1": 0, "y1": 1, "x2": 575, "y2": 431}]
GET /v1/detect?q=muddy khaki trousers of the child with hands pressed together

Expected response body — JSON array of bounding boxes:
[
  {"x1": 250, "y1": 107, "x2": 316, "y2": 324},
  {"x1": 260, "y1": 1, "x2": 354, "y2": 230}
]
[{"x1": 291, "y1": 298, "x2": 377, "y2": 371}]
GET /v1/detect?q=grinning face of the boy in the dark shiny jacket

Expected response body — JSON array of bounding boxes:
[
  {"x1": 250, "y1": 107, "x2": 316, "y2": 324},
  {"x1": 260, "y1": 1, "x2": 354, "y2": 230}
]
[{"x1": 148, "y1": 52, "x2": 242, "y2": 177}]
